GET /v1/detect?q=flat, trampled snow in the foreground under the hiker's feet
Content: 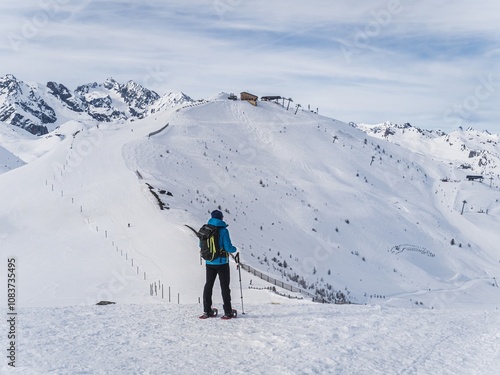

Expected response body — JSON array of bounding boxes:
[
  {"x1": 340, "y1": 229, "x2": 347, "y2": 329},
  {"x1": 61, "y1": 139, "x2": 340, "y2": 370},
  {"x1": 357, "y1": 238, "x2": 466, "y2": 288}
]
[{"x1": 0, "y1": 303, "x2": 500, "y2": 375}]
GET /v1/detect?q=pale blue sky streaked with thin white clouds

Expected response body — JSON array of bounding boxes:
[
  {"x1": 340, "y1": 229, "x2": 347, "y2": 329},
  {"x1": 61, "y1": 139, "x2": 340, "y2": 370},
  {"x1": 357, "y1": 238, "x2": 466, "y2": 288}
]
[{"x1": 0, "y1": 0, "x2": 500, "y2": 133}]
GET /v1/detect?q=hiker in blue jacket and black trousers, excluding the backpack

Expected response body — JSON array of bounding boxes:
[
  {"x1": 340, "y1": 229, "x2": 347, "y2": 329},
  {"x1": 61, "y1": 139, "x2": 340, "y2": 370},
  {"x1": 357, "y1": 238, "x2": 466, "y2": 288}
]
[{"x1": 200, "y1": 210, "x2": 237, "y2": 319}]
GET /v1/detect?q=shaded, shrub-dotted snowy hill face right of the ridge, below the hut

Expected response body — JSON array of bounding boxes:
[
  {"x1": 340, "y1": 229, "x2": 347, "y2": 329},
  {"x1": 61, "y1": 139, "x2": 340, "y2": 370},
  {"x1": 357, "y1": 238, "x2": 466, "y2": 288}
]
[{"x1": 124, "y1": 101, "x2": 498, "y2": 304}]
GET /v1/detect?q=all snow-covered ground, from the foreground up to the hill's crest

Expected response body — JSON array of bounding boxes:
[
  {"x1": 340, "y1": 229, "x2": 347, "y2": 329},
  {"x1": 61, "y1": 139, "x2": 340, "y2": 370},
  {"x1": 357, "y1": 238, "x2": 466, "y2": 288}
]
[{"x1": 0, "y1": 96, "x2": 500, "y2": 374}]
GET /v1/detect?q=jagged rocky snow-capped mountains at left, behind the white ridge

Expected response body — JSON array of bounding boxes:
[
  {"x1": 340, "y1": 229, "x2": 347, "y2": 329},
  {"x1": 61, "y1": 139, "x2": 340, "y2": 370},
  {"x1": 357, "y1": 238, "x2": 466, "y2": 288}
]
[{"x1": 0, "y1": 74, "x2": 193, "y2": 135}]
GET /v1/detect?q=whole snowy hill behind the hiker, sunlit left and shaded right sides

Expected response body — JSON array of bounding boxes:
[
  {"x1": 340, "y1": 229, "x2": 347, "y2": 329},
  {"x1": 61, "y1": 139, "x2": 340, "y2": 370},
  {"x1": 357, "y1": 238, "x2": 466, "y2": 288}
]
[{"x1": 0, "y1": 99, "x2": 500, "y2": 307}]
